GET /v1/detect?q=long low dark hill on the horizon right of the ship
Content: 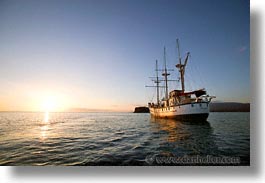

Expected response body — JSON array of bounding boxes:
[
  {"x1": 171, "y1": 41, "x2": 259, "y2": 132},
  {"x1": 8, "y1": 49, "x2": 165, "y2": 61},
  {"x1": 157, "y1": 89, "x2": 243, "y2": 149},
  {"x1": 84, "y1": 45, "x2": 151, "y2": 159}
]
[{"x1": 210, "y1": 102, "x2": 250, "y2": 112}]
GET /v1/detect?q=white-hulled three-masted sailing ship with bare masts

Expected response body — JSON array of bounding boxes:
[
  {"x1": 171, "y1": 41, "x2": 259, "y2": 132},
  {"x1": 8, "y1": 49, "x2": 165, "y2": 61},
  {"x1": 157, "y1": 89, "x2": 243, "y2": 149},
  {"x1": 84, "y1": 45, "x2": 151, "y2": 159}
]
[{"x1": 147, "y1": 39, "x2": 215, "y2": 121}]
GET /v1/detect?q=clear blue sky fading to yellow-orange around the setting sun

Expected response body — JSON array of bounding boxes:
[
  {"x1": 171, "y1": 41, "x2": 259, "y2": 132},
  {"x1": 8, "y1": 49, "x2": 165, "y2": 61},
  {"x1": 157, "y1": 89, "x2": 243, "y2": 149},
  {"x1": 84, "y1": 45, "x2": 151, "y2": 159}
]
[{"x1": 0, "y1": 0, "x2": 250, "y2": 111}]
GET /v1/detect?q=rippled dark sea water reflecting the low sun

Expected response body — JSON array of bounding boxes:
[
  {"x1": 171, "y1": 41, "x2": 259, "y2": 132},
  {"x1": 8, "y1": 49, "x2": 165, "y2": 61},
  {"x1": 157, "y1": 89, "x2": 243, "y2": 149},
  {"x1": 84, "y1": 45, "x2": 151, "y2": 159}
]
[{"x1": 0, "y1": 112, "x2": 250, "y2": 166}]
